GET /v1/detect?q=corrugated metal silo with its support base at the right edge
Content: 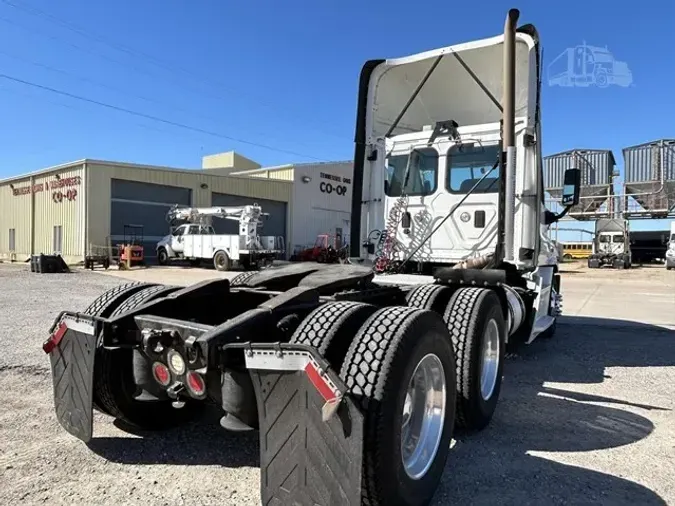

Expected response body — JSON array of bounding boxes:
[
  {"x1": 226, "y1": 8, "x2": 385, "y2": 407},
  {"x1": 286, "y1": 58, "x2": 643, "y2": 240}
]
[{"x1": 623, "y1": 139, "x2": 675, "y2": 218}]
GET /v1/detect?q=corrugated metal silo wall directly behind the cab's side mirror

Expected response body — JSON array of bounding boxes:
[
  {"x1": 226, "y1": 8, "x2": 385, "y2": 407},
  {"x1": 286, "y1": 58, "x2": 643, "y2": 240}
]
[{"x1": 544, "y1": 150, "x2": 614, "y2": 190}]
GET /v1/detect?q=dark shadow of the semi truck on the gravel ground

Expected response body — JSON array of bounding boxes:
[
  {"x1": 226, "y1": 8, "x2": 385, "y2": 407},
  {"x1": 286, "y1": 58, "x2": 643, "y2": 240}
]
[{"x1": 89, "y1": 317, "x2": 675, "y2": 506}]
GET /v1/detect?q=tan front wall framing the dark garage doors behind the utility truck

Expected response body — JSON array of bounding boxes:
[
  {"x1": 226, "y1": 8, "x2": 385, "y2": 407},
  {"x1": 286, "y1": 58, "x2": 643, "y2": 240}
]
[{"x1": 87, "y1": 161, "x2": 293, "y2": 255}]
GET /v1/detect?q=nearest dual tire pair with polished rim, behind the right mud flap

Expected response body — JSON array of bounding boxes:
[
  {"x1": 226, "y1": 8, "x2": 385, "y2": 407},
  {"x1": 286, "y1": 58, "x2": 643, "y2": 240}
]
[{"x1": 291, "y1": 302, "x2": 457, "y2": 506}]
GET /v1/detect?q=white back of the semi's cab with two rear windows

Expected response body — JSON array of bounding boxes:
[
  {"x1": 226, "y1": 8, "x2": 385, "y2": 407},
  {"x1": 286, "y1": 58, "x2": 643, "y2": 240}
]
[{"x1": 380, "y1": 123, "x2": 557, "y2": 273}]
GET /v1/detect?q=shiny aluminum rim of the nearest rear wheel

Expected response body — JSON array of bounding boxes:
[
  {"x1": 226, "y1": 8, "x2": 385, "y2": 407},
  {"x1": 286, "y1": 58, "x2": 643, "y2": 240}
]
[{"x1": 401, "y1": 353, "x2": 446, "y2": 480}]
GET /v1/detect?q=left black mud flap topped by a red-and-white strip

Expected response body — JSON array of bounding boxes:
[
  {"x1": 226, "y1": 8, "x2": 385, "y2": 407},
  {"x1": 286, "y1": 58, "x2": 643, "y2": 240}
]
[{"x1": 43, "y1": 313, "x2": 96, "y2": 443}]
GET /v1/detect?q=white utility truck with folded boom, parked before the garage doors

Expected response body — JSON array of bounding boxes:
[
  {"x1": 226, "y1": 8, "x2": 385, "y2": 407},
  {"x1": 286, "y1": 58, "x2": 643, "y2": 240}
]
[{"x1": 157, "y1": 204, "x2": 284, "y2": 271}]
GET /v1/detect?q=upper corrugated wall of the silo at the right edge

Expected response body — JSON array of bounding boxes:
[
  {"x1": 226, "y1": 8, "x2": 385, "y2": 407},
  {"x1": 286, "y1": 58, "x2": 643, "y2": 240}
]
[{"x1": 623, "y1": 140, "x2": 675, "y2": 183}]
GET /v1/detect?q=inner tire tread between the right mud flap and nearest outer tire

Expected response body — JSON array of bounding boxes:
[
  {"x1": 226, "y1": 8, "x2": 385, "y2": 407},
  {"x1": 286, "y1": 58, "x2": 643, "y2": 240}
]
[{"x1": 290, "y1": 301, "x2": 377, "y2": 371}]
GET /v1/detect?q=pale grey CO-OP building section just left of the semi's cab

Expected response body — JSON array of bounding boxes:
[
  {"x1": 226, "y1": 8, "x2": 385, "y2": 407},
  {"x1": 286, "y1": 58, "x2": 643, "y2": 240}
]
[{"x1": 231, "y1": 161, "x2": 354, "y2": 253}]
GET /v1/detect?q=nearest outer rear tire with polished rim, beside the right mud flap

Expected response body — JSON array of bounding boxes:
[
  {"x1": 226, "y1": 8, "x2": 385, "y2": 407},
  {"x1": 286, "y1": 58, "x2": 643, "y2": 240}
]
[{"x1": 340, "y1": 306, "x2": 456, "y2": 506}]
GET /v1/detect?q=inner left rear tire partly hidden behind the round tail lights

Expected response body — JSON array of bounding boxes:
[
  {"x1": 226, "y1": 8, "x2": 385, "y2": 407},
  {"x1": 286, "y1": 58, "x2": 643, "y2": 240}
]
[{"x1": 94, "y1": 285, "x2": 202, "y2": 430}]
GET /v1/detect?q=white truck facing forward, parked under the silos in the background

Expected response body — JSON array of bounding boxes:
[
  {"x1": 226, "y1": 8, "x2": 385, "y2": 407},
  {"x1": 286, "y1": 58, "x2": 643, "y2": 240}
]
[{"x1": 588, "y1": 218, "x2": 632, "y2": 269}]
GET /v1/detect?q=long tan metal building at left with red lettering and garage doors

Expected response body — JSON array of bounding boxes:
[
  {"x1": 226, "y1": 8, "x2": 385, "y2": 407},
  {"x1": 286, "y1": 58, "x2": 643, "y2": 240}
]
[{"x1": 0, "y1": 154, "x2": 293, "y2": 263}]
